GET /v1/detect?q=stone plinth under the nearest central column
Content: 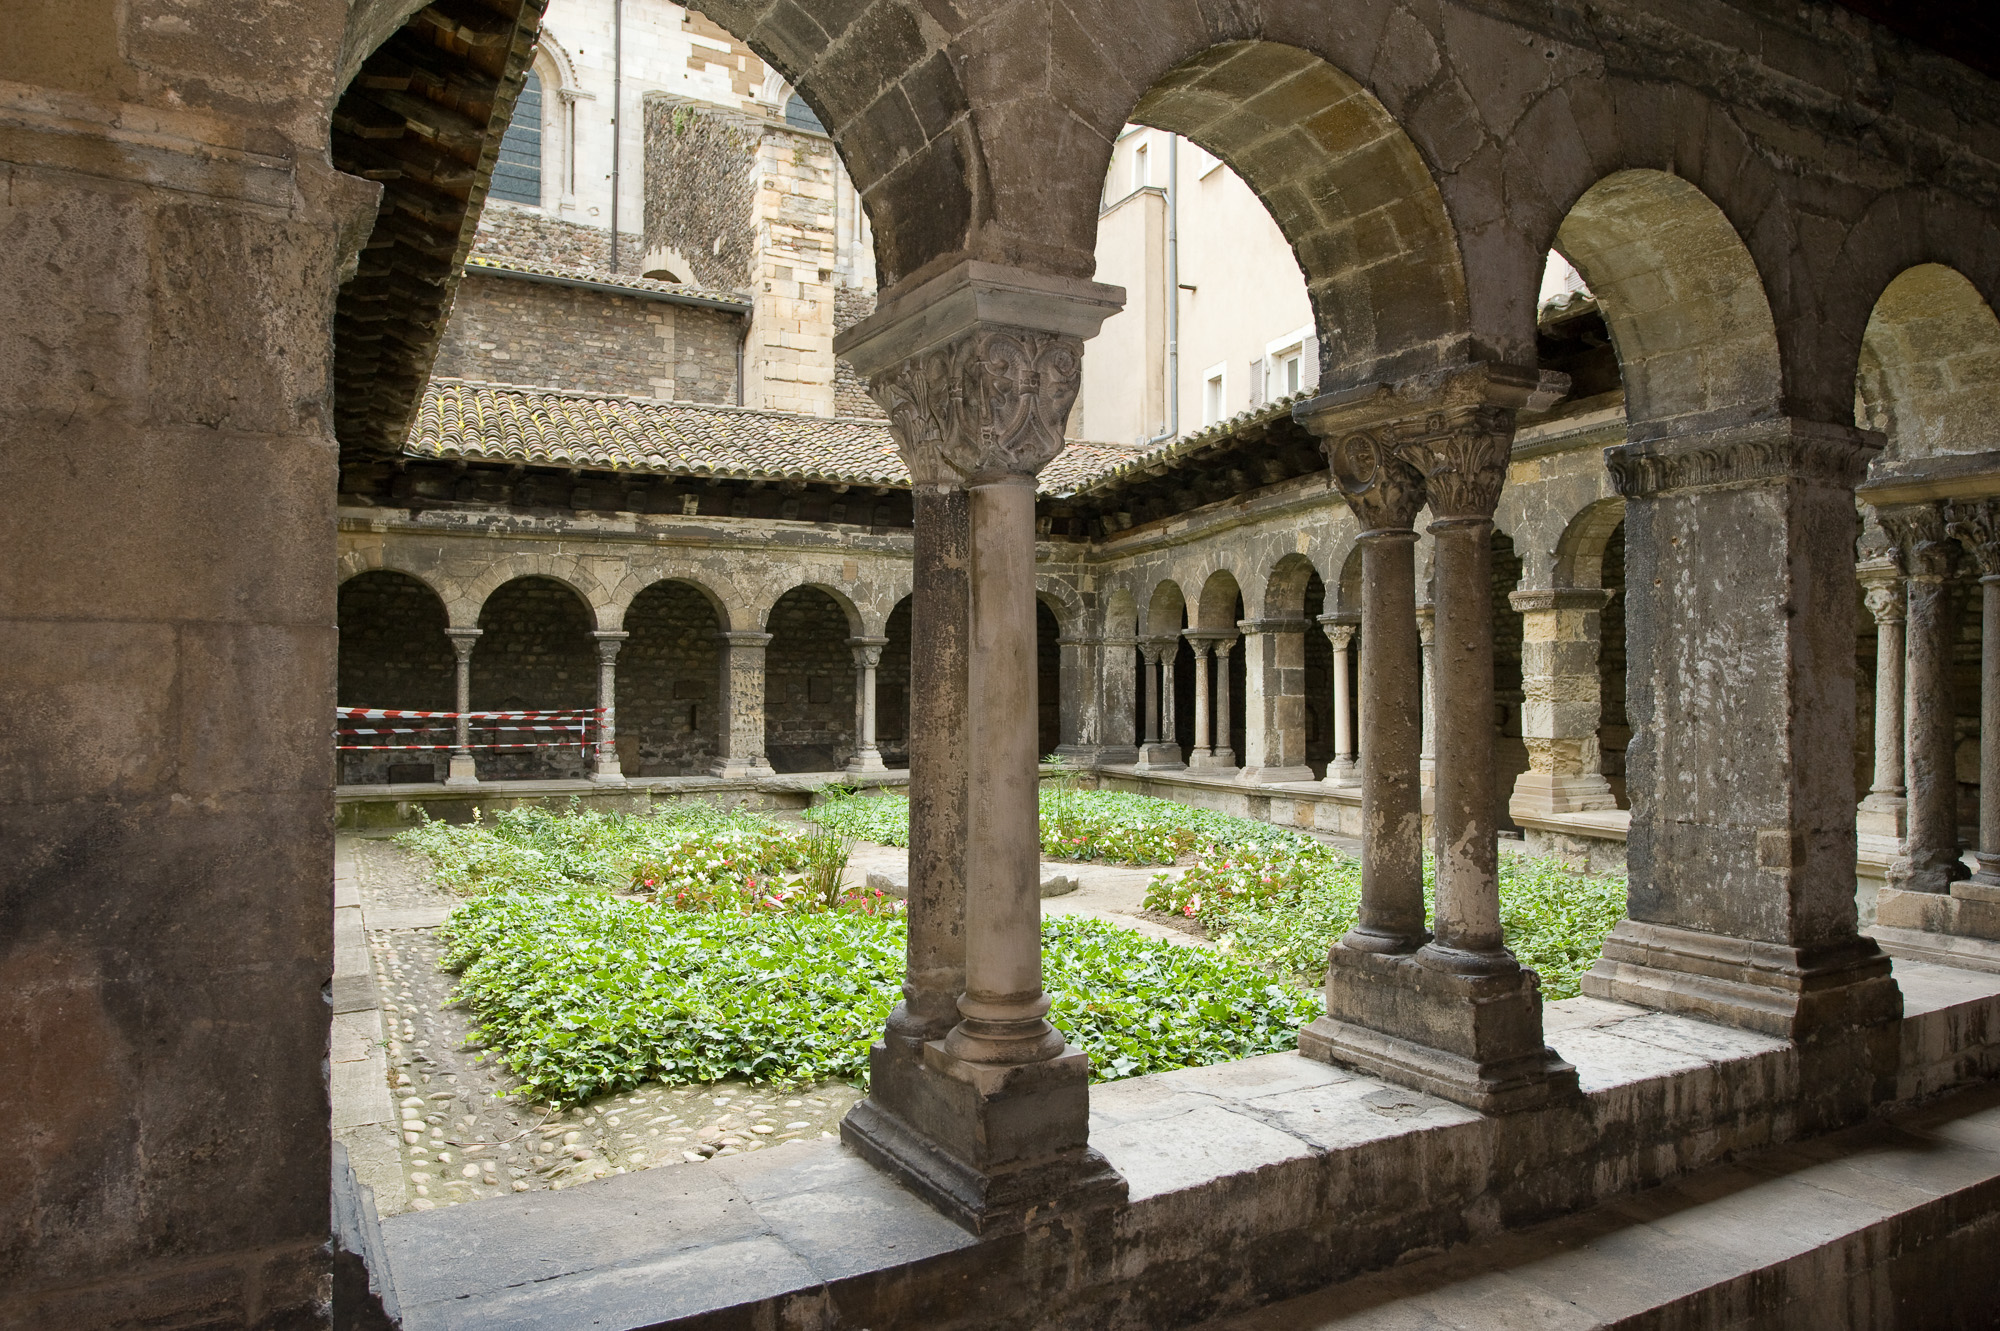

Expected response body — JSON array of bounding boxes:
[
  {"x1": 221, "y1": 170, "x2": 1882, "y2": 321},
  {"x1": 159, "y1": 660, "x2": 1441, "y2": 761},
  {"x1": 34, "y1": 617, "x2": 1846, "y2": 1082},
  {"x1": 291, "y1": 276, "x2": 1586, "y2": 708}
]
[{"x1": 840, "y1": 1039, "x2": 1126, "y2": 1237}]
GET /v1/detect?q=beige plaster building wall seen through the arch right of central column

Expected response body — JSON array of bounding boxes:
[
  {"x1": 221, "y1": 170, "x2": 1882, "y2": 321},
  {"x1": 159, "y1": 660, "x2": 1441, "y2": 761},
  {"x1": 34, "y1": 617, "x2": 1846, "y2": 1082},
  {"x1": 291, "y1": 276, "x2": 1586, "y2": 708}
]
[{"x1": 1070, "y1": 126, "x2": 1318, "y2": 442}]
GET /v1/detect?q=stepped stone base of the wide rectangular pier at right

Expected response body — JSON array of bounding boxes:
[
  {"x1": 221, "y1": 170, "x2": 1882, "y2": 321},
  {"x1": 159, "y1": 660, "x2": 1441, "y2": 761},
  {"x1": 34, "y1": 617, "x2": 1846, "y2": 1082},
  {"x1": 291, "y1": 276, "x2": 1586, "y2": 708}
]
[{"x1": 1582, "y1": 919, "x2": 1902, "y2": 1041}]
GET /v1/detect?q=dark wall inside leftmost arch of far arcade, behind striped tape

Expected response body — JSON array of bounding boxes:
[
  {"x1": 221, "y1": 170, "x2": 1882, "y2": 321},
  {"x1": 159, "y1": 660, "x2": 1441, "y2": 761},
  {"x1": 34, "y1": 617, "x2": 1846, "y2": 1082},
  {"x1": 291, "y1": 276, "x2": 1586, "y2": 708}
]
[{"x1": 336, "y1": 570, "x2": 458, "y2": 785}]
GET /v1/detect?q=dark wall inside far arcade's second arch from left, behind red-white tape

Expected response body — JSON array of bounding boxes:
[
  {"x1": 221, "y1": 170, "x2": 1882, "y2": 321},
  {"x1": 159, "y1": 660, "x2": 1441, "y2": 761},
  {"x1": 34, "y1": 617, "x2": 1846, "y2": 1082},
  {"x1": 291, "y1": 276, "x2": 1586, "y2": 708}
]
[{"x1": 472, "y1": 578, "x2": 598, "y2": 781}]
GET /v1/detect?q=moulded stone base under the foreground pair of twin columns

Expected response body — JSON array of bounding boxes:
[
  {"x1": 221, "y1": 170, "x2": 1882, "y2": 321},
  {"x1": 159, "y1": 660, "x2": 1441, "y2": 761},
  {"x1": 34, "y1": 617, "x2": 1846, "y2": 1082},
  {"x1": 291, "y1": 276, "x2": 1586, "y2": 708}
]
[{"x1": 1298, "y1": 945, "x2": 1578, "y2": 1113}]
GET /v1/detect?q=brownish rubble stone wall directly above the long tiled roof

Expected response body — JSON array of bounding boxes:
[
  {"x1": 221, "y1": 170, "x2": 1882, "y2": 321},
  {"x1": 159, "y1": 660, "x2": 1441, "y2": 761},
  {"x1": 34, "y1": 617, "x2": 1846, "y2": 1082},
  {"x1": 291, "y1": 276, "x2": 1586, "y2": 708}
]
[{"x1": 432, "y1": 272, "x2": 742, "y2": 402}]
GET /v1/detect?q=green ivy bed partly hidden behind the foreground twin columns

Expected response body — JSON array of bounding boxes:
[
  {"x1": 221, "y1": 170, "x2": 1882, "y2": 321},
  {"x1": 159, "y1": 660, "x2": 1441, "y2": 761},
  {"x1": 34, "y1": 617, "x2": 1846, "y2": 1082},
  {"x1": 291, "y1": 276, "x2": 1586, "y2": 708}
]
[{"x1": 1146, "y1": 837, "x2": 1626, "y2": 999}]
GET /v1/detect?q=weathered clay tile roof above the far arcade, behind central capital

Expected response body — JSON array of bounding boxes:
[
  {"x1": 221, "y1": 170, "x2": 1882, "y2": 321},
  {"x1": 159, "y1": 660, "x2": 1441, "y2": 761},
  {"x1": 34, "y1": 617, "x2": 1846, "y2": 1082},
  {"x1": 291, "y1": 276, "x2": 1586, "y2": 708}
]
[{"x1": 406, "y1": 380, "x2": 1246, "y2": 494}]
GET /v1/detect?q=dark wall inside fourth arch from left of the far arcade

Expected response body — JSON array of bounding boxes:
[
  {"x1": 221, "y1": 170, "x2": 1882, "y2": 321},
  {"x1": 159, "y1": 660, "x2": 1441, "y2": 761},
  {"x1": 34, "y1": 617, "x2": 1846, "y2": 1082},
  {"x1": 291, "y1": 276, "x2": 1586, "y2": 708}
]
[{"x1": 764, "y1": 588, "x2": 856, "y2": 771}]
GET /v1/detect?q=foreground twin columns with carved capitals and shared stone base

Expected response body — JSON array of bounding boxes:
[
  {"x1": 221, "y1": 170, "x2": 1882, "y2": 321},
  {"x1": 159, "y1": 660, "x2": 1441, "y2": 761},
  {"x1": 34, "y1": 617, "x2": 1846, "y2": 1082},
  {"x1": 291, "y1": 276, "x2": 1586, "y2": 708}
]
[{"x1": 1294, "y1": 366, "x2": 1576, "y2": 1113}]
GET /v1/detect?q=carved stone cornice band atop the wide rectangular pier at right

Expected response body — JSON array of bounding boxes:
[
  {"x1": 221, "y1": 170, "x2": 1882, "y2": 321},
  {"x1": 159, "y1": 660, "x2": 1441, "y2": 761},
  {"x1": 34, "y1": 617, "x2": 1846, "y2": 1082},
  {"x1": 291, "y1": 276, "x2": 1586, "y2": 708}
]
[{"x1": 1604, "y1": 418, "x2": 1882, "y2": 498}]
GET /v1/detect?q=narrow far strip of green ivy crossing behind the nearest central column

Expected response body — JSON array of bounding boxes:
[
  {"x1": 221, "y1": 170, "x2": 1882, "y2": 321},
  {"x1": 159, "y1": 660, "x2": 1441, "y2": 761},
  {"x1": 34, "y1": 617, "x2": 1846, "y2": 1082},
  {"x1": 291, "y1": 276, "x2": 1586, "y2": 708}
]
[{"x1": 806, "y1": 785, "x2": 1314, "y2": 865}]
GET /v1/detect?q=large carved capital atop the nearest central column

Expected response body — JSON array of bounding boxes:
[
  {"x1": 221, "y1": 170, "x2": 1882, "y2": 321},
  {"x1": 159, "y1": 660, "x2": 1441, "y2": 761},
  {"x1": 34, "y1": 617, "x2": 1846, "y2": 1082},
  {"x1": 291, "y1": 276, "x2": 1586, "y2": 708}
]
[{"x1": 834, "y1": 260, "x2": 1124, "y2": 486}]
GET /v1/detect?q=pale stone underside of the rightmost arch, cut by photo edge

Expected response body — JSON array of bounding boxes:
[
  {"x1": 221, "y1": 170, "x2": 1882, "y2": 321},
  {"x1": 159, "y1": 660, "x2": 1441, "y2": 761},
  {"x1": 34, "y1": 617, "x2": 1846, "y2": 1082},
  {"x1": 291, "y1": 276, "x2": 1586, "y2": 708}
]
[{"x1": 1854, "y1": 264, "x2": 2000, "y2": 458}]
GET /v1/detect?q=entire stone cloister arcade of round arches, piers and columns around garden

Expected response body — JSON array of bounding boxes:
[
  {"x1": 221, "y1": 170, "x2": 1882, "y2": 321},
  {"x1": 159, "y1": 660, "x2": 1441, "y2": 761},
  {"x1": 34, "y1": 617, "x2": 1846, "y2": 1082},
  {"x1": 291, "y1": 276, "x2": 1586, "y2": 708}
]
[{"x1": 11, "y1": 0, "x2": 2000, "y2": 1327}]
